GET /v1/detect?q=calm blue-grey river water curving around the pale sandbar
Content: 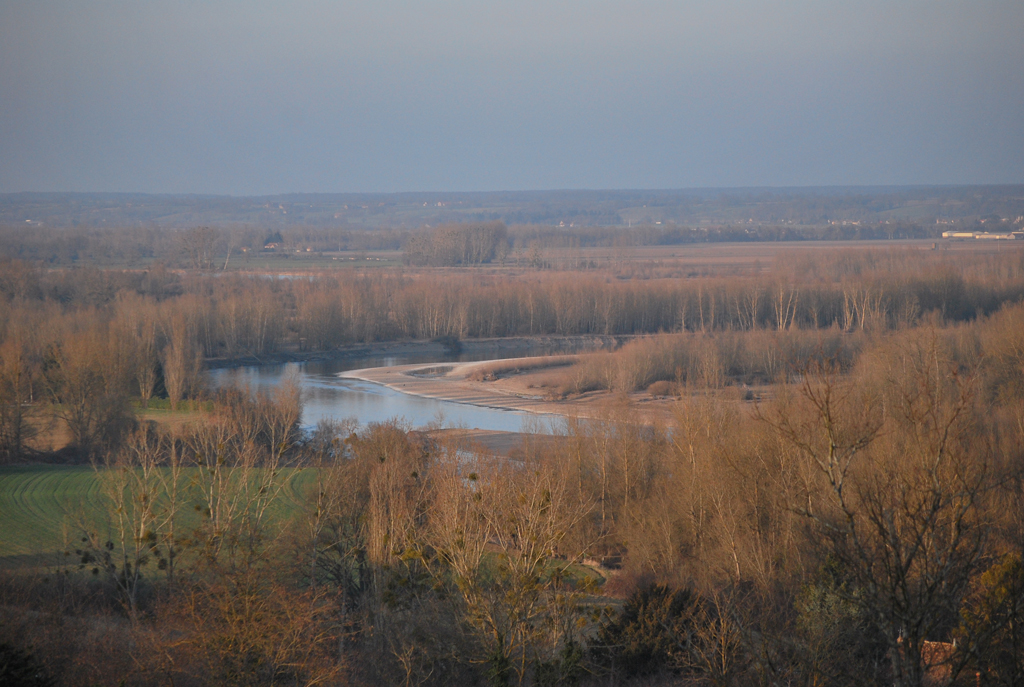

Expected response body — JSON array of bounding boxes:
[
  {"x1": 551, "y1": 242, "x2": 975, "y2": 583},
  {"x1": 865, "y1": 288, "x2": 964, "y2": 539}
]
[{"x1": 208, "y1": 352, "x2": 560, "y2": 433}]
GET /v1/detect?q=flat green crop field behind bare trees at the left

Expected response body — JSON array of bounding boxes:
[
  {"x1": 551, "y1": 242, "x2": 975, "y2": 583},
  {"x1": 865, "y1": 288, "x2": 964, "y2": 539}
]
[{"x1": 0, "y1": 465, "x2": 313, "y2": 567}]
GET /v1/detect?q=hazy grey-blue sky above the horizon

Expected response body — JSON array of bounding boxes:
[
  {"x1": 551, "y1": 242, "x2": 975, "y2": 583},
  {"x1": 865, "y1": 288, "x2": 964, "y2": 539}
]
[{"x1": 0, "y1": 0, "x2": 1024, "y2": 195}]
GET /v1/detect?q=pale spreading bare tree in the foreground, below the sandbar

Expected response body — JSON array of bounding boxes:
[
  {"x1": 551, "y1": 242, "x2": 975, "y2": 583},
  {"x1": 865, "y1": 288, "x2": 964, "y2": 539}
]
[{"x1": 428, "y1": 454, "x2": 589, "y2": 685}]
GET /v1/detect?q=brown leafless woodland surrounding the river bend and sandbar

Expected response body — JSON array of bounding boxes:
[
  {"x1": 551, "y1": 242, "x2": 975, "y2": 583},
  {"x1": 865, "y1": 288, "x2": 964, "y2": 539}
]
[{"x1": 0, "y1": 244, "x2": 1024, "y2": 687}]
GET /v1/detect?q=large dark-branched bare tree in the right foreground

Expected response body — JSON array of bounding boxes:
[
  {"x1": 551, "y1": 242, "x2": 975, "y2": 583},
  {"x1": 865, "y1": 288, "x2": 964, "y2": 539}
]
[{"x1": 762, "y1": 338, "x2": 990, "y2": 687}]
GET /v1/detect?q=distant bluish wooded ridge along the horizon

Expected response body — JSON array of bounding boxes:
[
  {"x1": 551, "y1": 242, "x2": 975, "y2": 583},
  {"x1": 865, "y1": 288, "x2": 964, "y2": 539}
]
[{"x1": 0, "y1": 185, "x2": 1024, "y2": 228}]
